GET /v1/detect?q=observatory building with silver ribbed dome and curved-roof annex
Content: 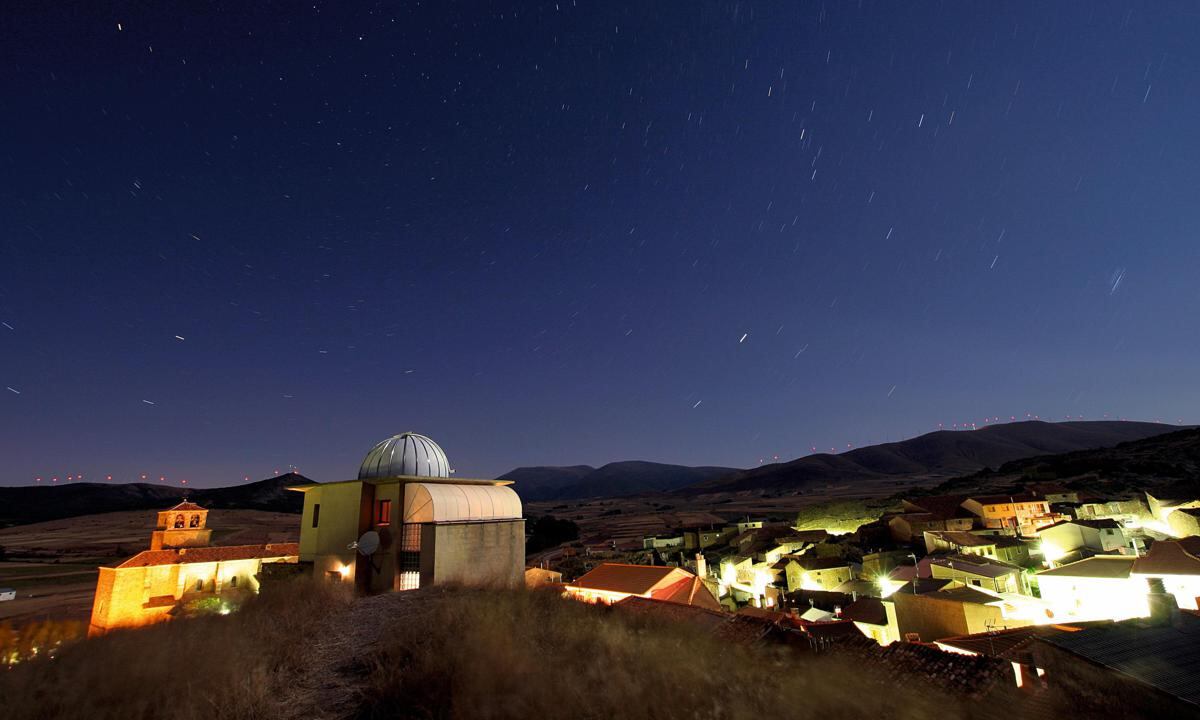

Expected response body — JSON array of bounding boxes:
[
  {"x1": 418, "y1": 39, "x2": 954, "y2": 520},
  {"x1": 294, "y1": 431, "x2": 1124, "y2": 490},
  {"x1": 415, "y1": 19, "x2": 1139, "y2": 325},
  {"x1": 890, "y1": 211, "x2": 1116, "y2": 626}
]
[{"x1": 290, "y1": 432, "x2": 524, "y2": 593}]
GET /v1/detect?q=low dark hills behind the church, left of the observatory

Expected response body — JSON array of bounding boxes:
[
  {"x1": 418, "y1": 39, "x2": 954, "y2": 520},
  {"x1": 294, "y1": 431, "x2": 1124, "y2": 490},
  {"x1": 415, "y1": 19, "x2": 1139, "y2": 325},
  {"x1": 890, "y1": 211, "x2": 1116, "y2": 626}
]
[{"x1": 0, "y1": 473, "x2": 311, "y2": 527}]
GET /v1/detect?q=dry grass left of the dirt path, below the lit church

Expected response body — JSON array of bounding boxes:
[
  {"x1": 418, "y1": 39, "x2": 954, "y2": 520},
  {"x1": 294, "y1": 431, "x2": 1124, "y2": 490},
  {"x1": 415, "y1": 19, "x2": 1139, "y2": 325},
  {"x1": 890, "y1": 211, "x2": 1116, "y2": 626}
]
[{"x1": 0, "y1": 583, "x2": 349, "y2": 720}]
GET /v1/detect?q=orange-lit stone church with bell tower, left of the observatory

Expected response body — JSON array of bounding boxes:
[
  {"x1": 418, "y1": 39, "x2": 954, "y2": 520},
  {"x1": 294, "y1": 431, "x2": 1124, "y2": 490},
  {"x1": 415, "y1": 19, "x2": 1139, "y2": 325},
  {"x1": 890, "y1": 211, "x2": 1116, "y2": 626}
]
[{"x1": 88, "y1": 500, "x2": 300, "y2": 635}]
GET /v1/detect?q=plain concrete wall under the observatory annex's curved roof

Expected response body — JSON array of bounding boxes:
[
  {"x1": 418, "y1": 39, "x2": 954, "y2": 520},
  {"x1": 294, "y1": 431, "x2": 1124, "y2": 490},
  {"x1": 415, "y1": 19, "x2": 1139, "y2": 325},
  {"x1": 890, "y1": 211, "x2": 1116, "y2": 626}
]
[{"x1": 421, "y1": 520, "x2": 524, "y2": 588}]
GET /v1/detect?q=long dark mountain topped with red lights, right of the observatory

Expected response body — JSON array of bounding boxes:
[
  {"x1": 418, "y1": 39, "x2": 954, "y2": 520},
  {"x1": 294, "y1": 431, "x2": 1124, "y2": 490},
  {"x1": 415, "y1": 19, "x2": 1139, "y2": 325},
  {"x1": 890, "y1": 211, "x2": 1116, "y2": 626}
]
[{"x1": 679, "y1": 421, "x2": 1176, "y2": 494}]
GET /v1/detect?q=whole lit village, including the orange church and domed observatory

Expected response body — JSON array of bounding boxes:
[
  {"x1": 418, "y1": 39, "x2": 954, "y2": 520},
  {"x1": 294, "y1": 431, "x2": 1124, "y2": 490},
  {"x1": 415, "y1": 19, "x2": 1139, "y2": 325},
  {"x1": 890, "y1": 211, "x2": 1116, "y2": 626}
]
[{"x1": 23, "y1": 433, "x2": 1185, "y2": 713}]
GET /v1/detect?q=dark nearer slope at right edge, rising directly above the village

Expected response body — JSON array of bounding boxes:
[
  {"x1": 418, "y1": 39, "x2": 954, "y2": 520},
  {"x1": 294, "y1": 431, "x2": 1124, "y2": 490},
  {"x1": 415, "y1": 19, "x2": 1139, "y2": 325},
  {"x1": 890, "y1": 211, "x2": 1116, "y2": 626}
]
[{"x1": 938, "y1": 428, "x2": 1200, "y2": 496}]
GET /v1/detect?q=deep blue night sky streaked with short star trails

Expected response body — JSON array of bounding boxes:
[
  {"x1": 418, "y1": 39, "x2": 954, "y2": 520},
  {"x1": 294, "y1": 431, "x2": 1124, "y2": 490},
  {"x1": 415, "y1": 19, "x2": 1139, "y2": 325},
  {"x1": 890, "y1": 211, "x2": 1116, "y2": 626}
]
[{"x1": 0, "y1": 0, "x2": 1200, "y2": 485}]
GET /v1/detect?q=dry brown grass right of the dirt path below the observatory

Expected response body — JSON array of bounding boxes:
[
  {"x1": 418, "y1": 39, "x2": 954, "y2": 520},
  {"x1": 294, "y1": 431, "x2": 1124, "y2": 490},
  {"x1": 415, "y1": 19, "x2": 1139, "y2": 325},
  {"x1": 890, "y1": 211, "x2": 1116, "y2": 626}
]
[{"x1": 360, "y1": 593, "x2": 950, "y2": 720}]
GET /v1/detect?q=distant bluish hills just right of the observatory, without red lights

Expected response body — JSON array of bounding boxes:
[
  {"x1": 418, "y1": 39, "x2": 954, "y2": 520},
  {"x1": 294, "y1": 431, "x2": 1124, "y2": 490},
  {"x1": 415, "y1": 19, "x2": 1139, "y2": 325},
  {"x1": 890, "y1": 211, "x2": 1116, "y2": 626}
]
[{"x1": 499, "y1": 460, "x2": 737, "y2": 502}]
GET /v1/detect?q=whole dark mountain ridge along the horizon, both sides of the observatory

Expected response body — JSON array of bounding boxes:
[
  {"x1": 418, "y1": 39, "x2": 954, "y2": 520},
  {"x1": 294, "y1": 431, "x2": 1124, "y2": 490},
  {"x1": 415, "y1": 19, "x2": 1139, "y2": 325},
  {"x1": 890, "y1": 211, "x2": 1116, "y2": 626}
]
[{"x1": 0, "y1": 421, "x2": 1180, "y2": 527}]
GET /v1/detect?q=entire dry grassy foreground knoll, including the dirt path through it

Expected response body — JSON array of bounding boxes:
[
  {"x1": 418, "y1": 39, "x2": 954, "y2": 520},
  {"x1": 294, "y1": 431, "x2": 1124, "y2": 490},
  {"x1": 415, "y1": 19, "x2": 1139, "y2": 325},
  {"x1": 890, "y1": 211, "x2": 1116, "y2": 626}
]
[{"x1": 0, "y1": 583, "x2": 956, "y2": 720}]
